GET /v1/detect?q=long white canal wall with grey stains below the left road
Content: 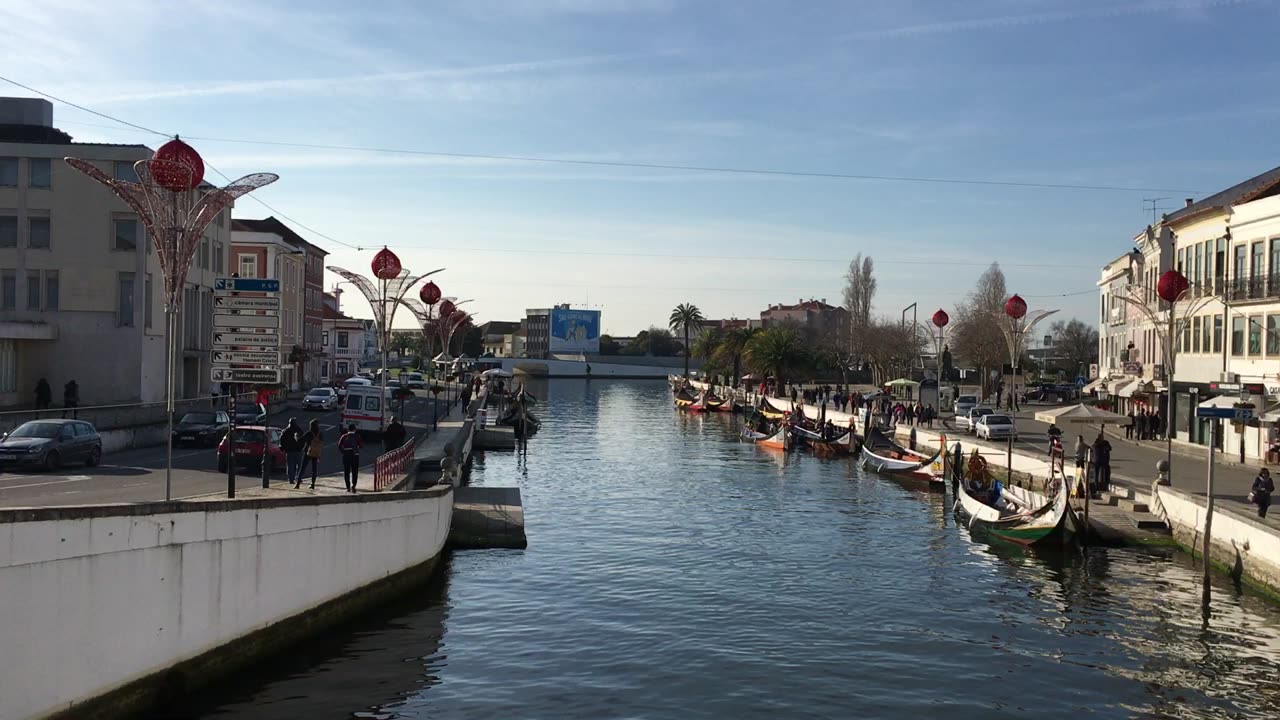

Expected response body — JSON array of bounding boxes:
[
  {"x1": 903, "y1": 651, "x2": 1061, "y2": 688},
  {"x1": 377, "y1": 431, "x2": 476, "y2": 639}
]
[{"x1": 0, "y1": 486, "x2": 453, "y2": 719}]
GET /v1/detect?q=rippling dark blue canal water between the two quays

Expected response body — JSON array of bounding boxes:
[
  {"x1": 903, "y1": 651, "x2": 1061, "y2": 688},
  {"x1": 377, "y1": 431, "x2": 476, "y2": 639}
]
[{"x1": 182, "y1": 380, "x2": 1280, "y2": 720}]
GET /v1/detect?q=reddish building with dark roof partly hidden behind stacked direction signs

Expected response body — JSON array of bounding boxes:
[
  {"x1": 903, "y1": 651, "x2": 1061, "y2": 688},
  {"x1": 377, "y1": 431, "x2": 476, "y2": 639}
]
[{"x1": 230, "y1": 220, "x2": 306, "y2": 389}]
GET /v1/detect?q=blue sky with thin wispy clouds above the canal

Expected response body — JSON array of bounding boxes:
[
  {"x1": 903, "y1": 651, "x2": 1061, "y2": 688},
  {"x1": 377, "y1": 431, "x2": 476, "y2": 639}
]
[{"x1": 0, "y1": 0, "x2": 1280, "y2": 336}]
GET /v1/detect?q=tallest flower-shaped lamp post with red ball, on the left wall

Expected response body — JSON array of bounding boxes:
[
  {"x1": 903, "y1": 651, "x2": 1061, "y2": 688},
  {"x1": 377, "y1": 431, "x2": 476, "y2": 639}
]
[{"x1": 64, "y1": 136, "x2": 280, "y2": 500}]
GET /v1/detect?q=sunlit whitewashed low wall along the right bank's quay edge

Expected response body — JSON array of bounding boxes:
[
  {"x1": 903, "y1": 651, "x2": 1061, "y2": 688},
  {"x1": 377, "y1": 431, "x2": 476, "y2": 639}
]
[{"x1": 1156, "y1": 486, "x2": 1280, "y2": 593}]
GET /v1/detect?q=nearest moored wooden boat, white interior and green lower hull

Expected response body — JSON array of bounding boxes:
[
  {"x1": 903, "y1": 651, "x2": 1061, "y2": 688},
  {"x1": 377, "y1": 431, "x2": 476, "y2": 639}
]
[{"x1": 956, "y1": 480, "x2": 1078, "y2": 546}]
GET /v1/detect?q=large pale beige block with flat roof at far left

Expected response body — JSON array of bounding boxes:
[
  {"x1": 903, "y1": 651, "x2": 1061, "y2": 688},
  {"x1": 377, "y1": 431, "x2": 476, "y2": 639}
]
[{"x1": 0, "y1": 97, "x2": 230, "y2": 406}]
